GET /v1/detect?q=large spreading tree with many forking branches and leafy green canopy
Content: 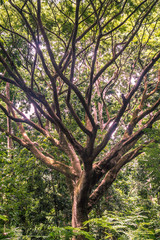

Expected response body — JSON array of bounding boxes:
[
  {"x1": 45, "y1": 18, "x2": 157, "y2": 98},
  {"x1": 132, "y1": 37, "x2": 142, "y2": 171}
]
[{"x1": 0, "y1": 0, "x2": 160, "y2": 236}]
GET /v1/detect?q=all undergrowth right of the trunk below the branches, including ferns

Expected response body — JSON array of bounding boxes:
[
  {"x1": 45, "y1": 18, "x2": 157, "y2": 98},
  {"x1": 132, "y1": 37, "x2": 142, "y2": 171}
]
[{"x1": 86, "y1": 156, "x2": 160, "y2": 240}]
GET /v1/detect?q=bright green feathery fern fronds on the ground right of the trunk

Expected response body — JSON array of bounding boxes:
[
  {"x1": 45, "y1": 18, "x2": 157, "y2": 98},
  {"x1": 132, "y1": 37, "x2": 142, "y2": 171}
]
[{"x1": 85, "y1": 209, "x2": 160, "y2": 240}]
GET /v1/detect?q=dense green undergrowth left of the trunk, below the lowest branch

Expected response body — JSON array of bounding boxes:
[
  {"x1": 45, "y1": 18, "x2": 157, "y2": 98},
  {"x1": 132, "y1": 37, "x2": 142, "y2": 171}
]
[{"x1": 0, "y1": 145, "x2": 71, "y2": 239}]
